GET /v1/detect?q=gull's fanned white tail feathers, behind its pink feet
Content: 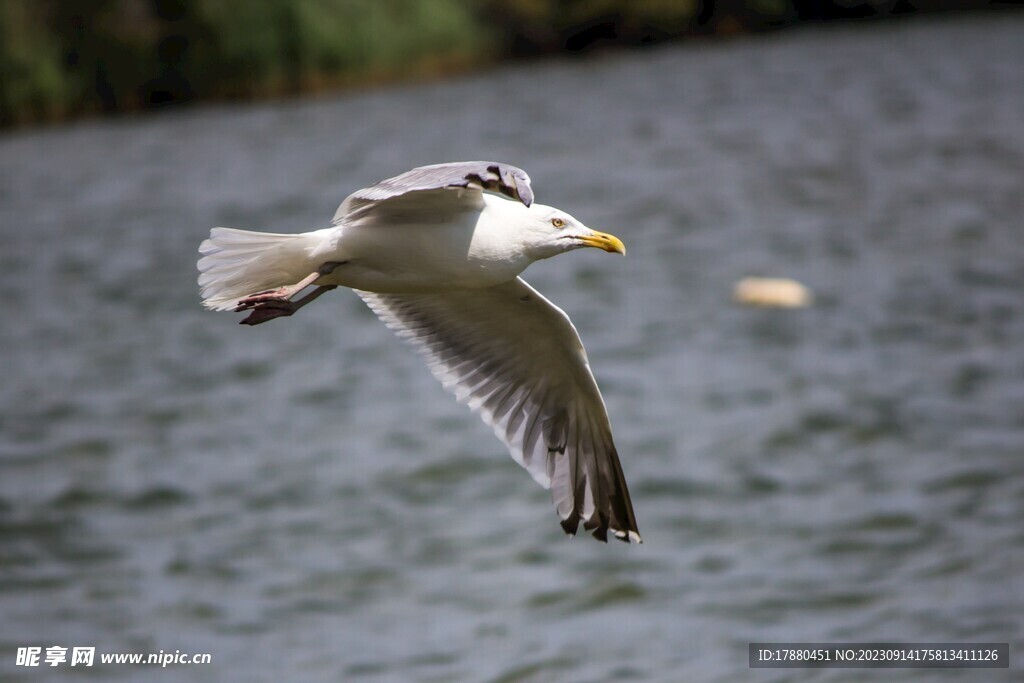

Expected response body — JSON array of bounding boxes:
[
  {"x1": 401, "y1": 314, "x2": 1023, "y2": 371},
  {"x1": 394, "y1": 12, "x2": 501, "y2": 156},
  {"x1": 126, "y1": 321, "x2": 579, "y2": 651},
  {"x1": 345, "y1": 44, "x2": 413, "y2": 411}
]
[{"x1": 199, "y1": 227, "x2": 311, "y2": 310}]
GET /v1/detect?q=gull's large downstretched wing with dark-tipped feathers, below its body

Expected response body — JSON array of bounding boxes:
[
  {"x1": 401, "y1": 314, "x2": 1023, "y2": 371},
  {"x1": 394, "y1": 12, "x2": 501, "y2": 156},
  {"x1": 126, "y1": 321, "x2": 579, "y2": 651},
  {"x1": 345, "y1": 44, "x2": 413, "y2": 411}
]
[{"x1": 358, "y1": 278, "x2": 640, "y2": 543}]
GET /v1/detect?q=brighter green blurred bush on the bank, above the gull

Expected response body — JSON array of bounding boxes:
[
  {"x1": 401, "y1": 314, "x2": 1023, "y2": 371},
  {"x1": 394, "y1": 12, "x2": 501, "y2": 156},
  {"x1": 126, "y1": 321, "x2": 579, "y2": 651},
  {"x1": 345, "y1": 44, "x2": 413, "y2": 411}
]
[{"x1": 175, "y1": 0, "x2": 481, "y2": 94}]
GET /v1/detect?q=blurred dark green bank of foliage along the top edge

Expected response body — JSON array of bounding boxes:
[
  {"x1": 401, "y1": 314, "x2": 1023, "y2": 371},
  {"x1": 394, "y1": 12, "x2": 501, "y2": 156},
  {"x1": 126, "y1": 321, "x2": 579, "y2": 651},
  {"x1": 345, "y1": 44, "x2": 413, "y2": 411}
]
[{"x1": 0, "y1": 0, "x2": 971, "y2": 125}]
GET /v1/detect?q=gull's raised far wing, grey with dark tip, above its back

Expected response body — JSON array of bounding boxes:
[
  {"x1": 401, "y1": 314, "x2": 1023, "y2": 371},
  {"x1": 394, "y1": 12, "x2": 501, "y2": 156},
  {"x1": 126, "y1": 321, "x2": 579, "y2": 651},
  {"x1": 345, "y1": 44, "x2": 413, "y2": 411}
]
[{"x1": 333, "y1": 161, "x2": 534, "y2": 225}]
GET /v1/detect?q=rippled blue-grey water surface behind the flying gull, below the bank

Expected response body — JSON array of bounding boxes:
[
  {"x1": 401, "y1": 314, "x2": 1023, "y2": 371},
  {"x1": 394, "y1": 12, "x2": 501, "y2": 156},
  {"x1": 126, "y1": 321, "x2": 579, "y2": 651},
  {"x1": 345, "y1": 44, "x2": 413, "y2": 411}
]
[{"x1": 0, "y1": 14, "x2": 1024, "y2": 682}]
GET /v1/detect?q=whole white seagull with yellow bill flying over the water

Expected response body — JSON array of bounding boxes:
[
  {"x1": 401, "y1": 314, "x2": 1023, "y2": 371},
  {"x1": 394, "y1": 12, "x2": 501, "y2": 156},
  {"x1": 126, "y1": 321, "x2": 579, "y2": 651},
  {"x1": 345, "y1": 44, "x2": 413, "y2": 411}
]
[{"x1": 199, "y1": 162, "x2": 642, "y2": 543}]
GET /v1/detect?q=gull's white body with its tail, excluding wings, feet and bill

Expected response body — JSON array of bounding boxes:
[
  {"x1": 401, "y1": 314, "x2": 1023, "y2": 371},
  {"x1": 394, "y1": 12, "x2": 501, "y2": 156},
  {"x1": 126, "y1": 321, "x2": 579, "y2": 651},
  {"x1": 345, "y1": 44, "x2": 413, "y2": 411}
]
[{"x1": 199, "y1": 189, "x2": 557, "y2": 310}]
